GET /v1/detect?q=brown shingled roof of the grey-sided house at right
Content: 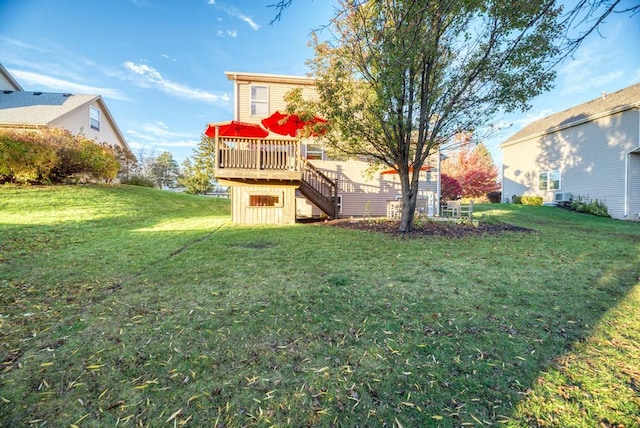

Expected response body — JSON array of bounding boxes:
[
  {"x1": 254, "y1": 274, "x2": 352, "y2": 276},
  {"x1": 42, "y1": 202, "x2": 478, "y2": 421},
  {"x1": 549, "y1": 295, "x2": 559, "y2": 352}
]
[{"x1": 501, "y1": 83, "x2": 640, "y2": 147}]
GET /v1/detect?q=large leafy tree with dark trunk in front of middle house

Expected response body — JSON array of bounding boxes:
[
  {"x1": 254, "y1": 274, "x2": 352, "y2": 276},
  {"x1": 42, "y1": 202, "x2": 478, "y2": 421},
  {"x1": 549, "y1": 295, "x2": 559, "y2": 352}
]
[{"x1": 310, "y1": 0, "x2": 561, "y2": 231}]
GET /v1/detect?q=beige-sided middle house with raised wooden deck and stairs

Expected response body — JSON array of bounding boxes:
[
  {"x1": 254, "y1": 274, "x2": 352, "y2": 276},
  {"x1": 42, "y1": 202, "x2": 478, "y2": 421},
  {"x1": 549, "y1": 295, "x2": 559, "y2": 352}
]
[{"x1": 214, "y1": 72, "x2": 437, "y2": 224}]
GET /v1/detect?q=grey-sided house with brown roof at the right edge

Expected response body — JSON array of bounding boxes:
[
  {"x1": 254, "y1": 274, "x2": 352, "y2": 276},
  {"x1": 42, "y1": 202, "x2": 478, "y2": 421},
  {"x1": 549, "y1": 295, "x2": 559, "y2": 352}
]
[{"x1": 500, "y1": 83, "x2": 640, "y2": 220}]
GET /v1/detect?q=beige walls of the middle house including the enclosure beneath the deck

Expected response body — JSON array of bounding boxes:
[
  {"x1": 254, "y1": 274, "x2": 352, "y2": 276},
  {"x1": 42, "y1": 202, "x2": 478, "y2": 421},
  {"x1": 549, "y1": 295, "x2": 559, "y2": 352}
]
[{"x1": 218, "y1": 72, "x2": 437, "y2": 224}]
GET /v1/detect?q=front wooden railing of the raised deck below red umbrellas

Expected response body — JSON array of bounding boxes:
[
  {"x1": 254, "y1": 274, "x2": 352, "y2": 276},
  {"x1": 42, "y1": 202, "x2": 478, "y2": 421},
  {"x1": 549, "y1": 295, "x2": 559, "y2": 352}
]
[{"x1": 216, "y1": 137, "x2": 300, "y2": 171}]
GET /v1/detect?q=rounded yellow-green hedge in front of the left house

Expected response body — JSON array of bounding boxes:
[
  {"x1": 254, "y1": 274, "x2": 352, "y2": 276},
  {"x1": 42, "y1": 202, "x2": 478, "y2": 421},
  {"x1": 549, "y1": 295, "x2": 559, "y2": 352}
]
[{"x1": 0, "y1": 128, "x2": 120, "y2": 184}]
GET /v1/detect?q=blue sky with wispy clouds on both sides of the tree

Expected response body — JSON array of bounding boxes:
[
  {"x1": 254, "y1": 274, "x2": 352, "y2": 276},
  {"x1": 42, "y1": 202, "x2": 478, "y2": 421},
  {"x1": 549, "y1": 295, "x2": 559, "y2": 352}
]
[{"x1": 0, "y1": 0, "x2": 640, "y2": 163}]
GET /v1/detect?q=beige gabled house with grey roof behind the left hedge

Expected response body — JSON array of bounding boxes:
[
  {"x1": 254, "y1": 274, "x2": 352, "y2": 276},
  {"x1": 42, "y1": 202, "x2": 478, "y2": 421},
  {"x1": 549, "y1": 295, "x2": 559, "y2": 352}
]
[{"x1": 0, "y1": 65, "x2": 133, "y2": 156}]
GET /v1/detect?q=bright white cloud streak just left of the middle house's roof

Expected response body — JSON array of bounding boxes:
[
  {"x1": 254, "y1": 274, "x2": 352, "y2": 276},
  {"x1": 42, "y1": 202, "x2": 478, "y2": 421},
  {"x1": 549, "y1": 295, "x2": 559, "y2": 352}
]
[{"x1": 124, "y1": 61, "x2": 231, "y2": 103}]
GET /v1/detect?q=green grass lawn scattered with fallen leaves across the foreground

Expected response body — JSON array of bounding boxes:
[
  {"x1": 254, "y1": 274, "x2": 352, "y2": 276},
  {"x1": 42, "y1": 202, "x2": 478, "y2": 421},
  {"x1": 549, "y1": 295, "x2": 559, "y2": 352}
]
[{"x1": 0, "y1": 186, "x2": 640, "y2": 427}]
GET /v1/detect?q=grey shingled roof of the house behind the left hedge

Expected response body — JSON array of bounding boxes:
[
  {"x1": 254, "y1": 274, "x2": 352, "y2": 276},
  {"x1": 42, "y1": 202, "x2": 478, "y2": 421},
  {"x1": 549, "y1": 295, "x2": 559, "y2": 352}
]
[{"x1": 0, "y1": 91, "x2": 133, "y2": 153}]
